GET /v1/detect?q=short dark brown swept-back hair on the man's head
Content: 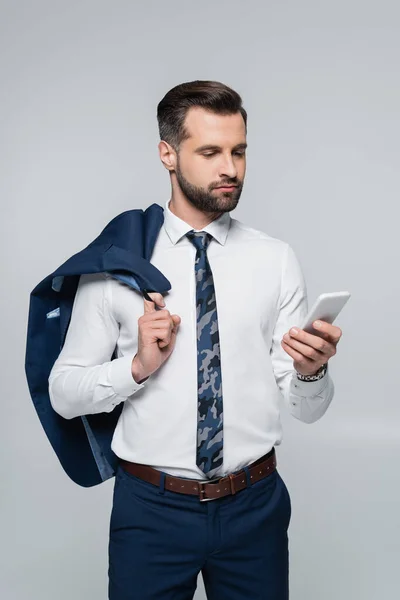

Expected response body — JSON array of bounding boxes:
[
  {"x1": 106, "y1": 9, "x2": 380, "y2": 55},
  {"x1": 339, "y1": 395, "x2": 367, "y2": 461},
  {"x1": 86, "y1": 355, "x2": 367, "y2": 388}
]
[{"x1": 157, "y1": 80, "x2": 247, "y2": 152}]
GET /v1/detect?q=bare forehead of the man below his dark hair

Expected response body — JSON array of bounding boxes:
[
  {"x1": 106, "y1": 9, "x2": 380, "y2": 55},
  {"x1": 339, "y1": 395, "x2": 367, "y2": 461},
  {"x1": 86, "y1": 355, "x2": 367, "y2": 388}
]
[{"x1": 185, "y1": 106, "x2": 246, "y2": 146}]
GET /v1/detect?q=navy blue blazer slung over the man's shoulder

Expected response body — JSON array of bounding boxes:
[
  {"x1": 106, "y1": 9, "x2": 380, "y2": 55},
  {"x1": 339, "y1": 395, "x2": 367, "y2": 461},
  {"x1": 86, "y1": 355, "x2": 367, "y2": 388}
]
[{"x1": 25, "y1": 204, "x2": 171, "y2": 487}]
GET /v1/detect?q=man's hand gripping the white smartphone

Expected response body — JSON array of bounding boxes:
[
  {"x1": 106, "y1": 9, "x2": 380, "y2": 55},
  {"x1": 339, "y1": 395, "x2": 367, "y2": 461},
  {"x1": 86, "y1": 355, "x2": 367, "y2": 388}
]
[{"x1": 281, "y1": 321, "x2": 342, "y2": 375}]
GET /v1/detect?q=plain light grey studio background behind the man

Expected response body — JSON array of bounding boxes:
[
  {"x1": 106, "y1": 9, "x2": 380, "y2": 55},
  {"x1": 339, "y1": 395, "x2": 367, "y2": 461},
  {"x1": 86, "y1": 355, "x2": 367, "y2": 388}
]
[{"x1": 0, "y1": 0, "x2": 400, "y2": 600}]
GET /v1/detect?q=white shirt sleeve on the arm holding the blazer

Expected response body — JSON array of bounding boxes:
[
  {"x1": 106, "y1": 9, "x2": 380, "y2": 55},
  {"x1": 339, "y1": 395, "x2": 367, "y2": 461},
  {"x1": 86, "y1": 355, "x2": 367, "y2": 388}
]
[{"x1": 48, "y1": 273, "x2": 148, "y2": 419}]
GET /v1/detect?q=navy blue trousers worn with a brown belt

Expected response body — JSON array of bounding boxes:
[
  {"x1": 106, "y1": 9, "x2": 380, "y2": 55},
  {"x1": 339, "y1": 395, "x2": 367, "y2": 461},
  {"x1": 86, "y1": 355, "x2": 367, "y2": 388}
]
[{"x1": 108, "y1": 465, "x2": 291, "y2": 600}]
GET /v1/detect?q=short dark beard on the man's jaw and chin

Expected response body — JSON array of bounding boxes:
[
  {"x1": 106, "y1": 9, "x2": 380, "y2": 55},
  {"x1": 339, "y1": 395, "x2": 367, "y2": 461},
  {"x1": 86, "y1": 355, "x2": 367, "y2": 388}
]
[{"x1": 175, "y1": 157, "x2": 243, "y2": 213}]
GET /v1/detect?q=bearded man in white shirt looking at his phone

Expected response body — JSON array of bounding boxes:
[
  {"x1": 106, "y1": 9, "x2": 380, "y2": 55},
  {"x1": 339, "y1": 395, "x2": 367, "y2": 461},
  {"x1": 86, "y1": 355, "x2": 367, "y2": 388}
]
[{"x1": 49, "y1": 81, "x2": 342, "y2": 600}]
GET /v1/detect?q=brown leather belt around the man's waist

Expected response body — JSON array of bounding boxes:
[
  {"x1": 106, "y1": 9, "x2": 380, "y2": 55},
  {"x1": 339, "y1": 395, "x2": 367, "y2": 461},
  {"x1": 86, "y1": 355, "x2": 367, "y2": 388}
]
[{"x1": 120, "y1": 448, "x2": 276, "y2": 502}]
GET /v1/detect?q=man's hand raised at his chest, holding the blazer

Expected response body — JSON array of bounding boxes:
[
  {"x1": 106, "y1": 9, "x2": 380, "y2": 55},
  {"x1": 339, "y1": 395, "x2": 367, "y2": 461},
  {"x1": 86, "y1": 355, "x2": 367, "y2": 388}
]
[{"x1": 132, "y1": 292, "x2": 181, "y2": 383}]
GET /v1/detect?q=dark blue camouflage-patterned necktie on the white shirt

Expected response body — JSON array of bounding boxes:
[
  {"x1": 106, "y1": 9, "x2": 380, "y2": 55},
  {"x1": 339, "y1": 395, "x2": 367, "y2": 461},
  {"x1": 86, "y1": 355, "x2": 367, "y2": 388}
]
[{"x1": 186, "y1": 230, "x2": 223, "y2": 478}]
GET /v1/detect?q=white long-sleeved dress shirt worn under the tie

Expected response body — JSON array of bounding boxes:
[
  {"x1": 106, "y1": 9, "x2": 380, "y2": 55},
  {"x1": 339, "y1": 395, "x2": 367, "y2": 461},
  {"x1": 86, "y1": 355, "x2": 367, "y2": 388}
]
[{"x1": 49, "y1": 200, "x2": 334, "y2": 480}]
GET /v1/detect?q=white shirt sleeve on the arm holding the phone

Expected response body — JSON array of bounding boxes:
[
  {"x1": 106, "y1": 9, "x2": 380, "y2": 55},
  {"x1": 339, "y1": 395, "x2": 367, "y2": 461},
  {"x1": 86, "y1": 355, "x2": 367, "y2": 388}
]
[{"x1": 271, "y1": 244, "x2": 334, "y2": 423}]
